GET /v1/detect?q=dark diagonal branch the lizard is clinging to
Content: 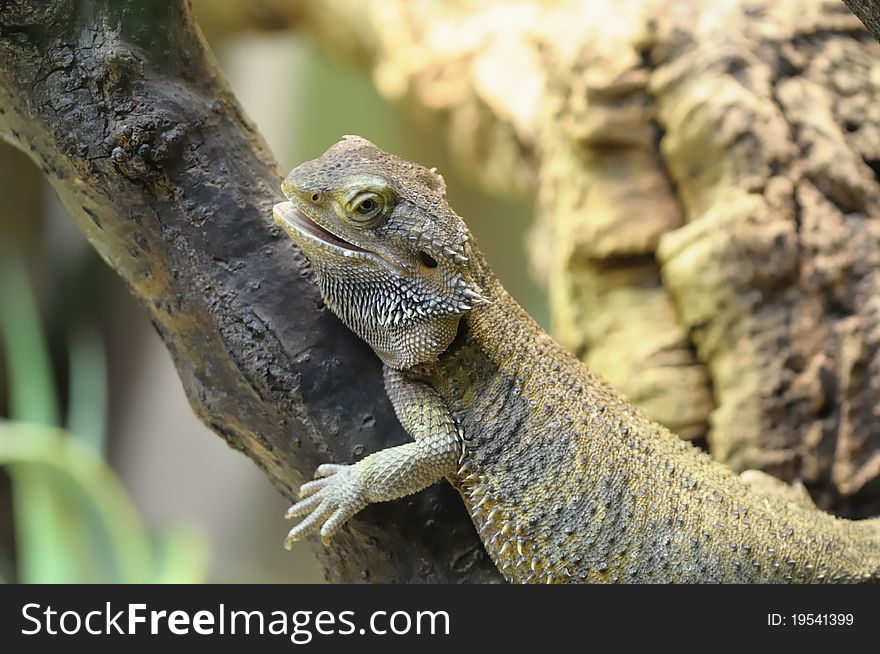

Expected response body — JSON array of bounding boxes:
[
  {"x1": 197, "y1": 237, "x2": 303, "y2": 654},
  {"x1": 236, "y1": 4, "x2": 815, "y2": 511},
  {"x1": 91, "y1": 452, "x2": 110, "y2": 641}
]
[{"x1": 0, "y1": 0, "x2": 500, "y2": 582}]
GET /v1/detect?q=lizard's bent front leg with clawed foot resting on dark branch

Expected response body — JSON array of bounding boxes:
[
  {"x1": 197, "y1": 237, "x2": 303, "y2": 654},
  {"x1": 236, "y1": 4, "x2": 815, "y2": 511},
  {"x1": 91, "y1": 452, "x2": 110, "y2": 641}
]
[{"x1": 285, "y1": 366, "x2": 462, "y2": 549}]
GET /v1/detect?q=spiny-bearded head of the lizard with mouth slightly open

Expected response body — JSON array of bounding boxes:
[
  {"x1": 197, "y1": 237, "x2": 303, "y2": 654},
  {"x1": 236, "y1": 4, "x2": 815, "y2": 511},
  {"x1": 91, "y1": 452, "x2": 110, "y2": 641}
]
[{"x1": 273, "y1": 136, "x2": 486, "y2": 368}]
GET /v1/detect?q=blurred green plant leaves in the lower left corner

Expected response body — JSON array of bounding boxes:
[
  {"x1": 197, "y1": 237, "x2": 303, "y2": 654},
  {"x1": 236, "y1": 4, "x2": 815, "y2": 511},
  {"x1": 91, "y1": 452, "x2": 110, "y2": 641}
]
[{"x1": 0, "y1": 253, "x2": 207, "y2": 583}]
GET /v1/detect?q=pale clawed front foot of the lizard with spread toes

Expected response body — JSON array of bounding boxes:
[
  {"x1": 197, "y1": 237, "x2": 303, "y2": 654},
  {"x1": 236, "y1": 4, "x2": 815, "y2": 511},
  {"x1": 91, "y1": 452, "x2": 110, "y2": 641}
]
[{"x1": 284, "y1": 463, "x2": 368, "y2": 549}]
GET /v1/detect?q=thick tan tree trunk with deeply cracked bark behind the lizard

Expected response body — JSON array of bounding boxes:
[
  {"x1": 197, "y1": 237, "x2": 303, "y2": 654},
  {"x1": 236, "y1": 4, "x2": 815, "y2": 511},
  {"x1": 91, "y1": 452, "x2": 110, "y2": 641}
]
[{"x1": 205, "y1": 0, "x2": 880, "y2": 516}]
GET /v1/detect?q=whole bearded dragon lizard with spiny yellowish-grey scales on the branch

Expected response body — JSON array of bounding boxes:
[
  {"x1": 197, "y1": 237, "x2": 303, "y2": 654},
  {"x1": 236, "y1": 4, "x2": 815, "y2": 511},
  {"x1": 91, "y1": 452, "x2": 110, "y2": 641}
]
[{"x1": 275, "y1": 137, "x2": 880, "y2": 582}]
